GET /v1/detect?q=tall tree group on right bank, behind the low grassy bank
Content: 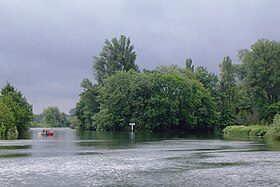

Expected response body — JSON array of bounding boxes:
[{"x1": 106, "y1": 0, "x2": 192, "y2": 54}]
[{"x1": 220, "y1": 39, "x2": 280, "y2": 126}]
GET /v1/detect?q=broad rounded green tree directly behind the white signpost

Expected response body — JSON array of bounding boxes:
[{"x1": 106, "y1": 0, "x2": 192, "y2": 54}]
[{"x1": 93, "y1": 66, "x2": 217, "y2": 131}]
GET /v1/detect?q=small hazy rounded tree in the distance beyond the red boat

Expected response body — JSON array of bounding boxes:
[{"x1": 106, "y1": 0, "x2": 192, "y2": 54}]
[{"x1": 43, "y1": 106, "x2": 70, "y2": 127}]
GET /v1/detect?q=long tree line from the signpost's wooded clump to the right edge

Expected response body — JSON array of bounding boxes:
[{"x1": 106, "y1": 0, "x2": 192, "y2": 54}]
[{"x1": 71, "y1": 36, "x2": 280, "y2": 131}]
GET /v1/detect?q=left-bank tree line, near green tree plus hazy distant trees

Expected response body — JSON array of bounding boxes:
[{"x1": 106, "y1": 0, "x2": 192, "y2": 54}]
[{"x1": 0, "y1": 82, "x2": 70, "y2": 138}]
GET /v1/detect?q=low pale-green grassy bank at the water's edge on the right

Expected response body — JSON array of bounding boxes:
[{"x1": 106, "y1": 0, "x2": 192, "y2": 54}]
[{"x1": 223, "y1": 125, "x2": 270, "y2": 138}]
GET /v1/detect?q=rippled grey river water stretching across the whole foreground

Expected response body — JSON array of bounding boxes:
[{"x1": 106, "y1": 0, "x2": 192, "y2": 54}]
[{"x1": 0, "y1": 129, "x2": 280, "y2": 187}]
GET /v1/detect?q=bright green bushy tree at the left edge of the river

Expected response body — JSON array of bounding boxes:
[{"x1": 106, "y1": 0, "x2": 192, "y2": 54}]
[{"x1": 0, "y1": 83, "x2": 33, "y2": 137}]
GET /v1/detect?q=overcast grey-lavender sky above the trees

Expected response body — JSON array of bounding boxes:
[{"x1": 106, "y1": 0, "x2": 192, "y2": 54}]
[{"x1": 0, "y1": 0, "x2": 280, "y2": 114}]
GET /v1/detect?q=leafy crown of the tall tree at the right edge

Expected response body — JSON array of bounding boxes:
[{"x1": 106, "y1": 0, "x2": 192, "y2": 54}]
[{"x1": 239, "y1": 39, "x2": 280, "y2": 104}]
